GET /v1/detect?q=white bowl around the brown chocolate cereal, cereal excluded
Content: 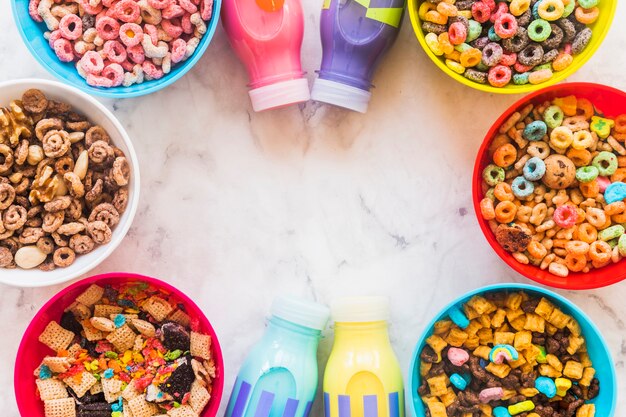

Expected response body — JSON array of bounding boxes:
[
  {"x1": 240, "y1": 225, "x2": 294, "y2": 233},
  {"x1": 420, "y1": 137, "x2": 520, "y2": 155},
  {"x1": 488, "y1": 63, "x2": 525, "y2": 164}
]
[{"x1": 0, "y1": 79, "x2": 140, "y2": 287}]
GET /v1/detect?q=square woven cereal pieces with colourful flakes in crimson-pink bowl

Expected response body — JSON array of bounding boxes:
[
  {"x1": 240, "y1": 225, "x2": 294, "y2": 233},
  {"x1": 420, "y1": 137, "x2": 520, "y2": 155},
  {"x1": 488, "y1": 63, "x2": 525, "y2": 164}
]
[{"x1": 35, "y1": 282, "x2": 216, "y2": 417}]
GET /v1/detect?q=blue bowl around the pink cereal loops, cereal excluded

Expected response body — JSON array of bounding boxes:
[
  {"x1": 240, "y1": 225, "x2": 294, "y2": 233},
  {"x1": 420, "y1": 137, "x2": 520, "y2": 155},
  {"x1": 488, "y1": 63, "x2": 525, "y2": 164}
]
[{"x1": 11, "y1": 0, "x2": 222, "y2": 98}]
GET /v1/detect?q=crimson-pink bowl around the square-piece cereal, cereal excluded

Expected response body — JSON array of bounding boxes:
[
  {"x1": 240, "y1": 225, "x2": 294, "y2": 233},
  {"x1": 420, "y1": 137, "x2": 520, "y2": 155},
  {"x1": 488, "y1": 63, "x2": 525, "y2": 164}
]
[{"x1": 14, "y1": 272, "x2": 224, "y2": 417}]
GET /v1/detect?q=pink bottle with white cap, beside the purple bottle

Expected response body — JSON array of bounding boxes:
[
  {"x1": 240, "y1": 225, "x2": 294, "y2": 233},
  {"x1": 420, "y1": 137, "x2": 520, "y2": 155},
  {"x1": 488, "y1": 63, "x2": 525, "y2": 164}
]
[{"x1": 222, "y1": 0, "x2": 310, "y2": 111}]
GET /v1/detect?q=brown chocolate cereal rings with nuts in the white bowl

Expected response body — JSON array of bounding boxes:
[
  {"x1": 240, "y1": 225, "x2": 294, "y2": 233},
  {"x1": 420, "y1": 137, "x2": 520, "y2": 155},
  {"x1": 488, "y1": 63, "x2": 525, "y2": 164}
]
[{"x1": 0, "y1": 89, "x2": 130, "y2": 271}]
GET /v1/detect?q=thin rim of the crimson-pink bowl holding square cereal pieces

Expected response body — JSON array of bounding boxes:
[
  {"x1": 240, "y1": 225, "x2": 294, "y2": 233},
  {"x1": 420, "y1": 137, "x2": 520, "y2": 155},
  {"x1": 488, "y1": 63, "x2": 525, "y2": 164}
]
[{"x1": 13, "y1": 272, "x2": 226, "y2": 415}]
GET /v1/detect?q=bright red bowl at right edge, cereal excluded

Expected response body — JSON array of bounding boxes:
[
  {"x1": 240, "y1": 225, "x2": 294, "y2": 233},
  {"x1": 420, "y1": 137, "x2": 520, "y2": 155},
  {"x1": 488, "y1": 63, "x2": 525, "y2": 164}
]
[{"x1": 472, "y1": 83, "x2": 626, "y2": 290}]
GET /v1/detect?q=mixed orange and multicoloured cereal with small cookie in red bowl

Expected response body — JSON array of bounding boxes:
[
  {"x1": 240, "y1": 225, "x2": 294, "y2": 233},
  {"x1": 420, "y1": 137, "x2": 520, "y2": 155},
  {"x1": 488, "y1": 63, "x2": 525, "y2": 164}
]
[{"x1": 480, "y1": 96, "x2": 626, "y2": 277}]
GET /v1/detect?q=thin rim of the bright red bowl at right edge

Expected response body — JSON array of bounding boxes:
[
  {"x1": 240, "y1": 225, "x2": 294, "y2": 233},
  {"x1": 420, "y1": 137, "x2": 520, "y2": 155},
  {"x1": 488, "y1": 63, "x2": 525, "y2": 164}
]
[{"x1": 472, "y1": 82, "x2": 626, "y2": 290}]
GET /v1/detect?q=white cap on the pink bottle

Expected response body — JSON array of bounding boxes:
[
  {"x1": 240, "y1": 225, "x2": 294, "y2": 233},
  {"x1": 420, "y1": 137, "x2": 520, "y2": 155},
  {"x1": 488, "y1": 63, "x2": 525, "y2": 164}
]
[{"x1": 249, "y1": 78, "x2": 311, "y2": 111}]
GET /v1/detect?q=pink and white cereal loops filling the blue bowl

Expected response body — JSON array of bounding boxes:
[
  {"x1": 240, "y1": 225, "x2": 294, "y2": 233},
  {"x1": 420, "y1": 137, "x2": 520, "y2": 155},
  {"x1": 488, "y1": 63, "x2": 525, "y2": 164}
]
[{"x1": 28, "y1": 0, "x2": 213, "y2": 88}]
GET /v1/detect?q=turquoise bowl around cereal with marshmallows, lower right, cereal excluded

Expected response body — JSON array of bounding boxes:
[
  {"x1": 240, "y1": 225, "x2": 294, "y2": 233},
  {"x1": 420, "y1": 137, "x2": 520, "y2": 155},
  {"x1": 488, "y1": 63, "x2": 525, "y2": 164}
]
[{"x1": 407, "y1": 284, "x2": 617, "y2": 417}]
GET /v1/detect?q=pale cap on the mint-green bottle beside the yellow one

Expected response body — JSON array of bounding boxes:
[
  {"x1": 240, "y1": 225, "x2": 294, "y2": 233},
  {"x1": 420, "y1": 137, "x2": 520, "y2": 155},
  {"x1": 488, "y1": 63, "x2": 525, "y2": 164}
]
[{"x1": 270, "y1": 297, "x2": 330, "y2": 331}]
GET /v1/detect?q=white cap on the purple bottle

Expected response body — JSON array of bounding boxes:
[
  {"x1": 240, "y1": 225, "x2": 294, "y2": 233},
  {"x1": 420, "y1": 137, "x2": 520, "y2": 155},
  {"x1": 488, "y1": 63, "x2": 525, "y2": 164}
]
[{"x1": 311, "y1": 78, "x2": 372, "y2": 113}]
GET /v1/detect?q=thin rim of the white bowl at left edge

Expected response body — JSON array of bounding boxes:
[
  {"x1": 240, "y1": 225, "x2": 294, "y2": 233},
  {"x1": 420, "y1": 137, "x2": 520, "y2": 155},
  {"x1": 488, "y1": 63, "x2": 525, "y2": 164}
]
[{"x1": 0, "y1": 78, "x2": 141, "y2": 288}]
